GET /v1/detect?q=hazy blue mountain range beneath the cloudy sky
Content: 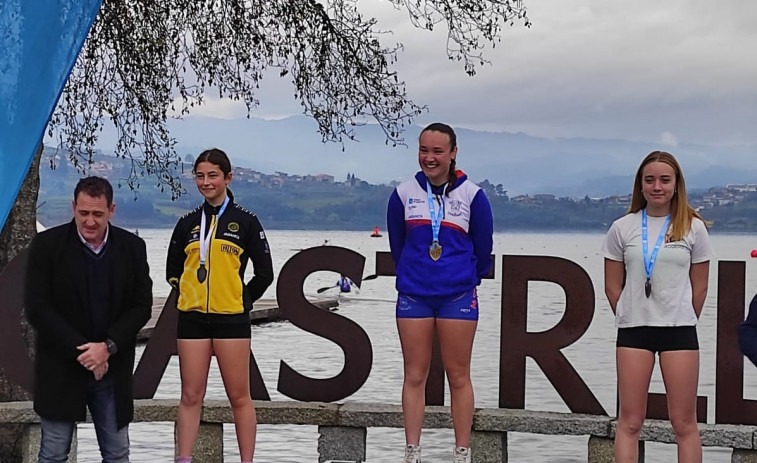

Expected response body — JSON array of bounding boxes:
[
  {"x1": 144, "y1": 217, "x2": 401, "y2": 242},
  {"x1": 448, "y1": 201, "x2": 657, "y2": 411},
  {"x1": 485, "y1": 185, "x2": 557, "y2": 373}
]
[{"x1": 94, "y1": 116, "x2": 757, "y2": 196}]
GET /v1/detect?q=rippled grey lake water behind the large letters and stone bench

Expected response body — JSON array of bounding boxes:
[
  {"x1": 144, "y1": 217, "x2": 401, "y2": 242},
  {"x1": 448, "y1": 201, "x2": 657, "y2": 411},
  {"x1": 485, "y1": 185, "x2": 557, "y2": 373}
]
[{"x1": 79, "y1": 229, "x2": 757, "y2": 463}]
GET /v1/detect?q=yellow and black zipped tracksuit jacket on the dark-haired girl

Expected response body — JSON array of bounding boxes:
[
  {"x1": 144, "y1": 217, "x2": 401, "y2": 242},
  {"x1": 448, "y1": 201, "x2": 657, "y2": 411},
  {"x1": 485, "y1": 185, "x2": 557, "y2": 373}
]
[{"x1": 166, "y1": 198, "x2": 273, "y2": 322}]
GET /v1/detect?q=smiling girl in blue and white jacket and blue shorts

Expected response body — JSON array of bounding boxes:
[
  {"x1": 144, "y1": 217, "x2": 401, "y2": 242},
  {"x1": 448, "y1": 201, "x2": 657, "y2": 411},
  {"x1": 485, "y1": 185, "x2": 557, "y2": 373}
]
[{"x1": 387, "y1": 123, "x2": 493, "y2": 463}]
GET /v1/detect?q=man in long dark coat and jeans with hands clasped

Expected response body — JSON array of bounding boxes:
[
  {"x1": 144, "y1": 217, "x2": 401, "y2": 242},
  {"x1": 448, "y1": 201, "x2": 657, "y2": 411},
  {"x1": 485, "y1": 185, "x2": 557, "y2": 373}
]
[{"x1": 25, "y1": 177, "x2": 152, "y2": 463}]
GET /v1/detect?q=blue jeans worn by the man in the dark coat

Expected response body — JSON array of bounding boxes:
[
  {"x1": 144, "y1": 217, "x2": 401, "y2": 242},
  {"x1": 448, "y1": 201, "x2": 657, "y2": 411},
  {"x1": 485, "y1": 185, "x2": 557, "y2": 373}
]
[{"x1": 39, "y1": 376, "x2": 129, "y2": 463}]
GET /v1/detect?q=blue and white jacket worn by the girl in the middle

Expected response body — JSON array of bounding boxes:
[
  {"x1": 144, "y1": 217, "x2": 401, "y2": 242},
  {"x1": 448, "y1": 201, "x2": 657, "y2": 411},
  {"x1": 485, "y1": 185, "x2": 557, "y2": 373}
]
[{"x1": 387, "y1": 170, "x2": 494, "y2": 297}]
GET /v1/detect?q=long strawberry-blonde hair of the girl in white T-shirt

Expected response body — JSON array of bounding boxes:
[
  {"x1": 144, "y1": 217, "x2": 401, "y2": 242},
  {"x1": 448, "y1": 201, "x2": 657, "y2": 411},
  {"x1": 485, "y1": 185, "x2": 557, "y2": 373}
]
[{"x1": 628, "y1": 151, "x2": 709, "y2": 241}]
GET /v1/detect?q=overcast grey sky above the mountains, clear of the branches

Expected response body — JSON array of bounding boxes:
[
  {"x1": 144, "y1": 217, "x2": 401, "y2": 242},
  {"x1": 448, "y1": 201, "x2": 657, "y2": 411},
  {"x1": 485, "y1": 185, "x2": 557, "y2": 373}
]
[{"x1": 182, "y1": 0, "x2": 757, "y2": 146}]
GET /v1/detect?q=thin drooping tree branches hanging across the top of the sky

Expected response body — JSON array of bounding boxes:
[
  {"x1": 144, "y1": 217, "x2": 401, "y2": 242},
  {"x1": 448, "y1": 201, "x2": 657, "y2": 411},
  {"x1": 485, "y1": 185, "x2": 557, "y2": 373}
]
[{"x1": 48, "y1": 0, "x2": 530, "y2": 198}]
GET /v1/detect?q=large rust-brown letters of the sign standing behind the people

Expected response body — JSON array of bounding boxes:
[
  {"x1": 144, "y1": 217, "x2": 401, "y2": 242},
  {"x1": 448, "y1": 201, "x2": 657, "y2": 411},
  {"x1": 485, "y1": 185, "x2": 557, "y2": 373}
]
[{"x1": 0, "y1": 246, "x2": 757, "y2": 424}]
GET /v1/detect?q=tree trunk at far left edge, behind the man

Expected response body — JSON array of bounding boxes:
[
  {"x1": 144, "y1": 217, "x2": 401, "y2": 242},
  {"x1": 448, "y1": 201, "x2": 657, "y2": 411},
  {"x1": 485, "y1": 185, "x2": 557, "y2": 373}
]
[{"x1": 0, "y1": 144, "x2": 43, "y2": 463}]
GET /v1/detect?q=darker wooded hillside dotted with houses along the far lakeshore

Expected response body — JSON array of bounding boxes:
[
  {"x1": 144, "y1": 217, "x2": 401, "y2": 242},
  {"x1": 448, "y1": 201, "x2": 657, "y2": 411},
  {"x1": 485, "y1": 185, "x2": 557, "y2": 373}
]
[{"x1": 37, "y1": 150, "x2": 757, "y2": 232}]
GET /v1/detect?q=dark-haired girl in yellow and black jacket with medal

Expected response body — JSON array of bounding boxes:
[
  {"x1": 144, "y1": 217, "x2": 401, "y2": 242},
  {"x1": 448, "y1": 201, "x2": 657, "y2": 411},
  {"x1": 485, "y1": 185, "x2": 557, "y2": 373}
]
[{"x1": 166, "y1": 149, "x2": 273, "y2": 463}]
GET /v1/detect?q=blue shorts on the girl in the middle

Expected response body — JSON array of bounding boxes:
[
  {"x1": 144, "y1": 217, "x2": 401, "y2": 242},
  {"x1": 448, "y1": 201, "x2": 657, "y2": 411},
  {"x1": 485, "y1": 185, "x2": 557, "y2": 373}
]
[{"x1": 397, "y1": 287, "x2": 478, "y2": 321}]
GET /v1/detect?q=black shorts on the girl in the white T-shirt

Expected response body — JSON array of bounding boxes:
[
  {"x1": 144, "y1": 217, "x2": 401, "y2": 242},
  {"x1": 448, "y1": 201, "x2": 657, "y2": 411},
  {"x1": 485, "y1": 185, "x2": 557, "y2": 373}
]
[{"x1": 615, "y1": 326, "x2": 699, "y2": 352}]
